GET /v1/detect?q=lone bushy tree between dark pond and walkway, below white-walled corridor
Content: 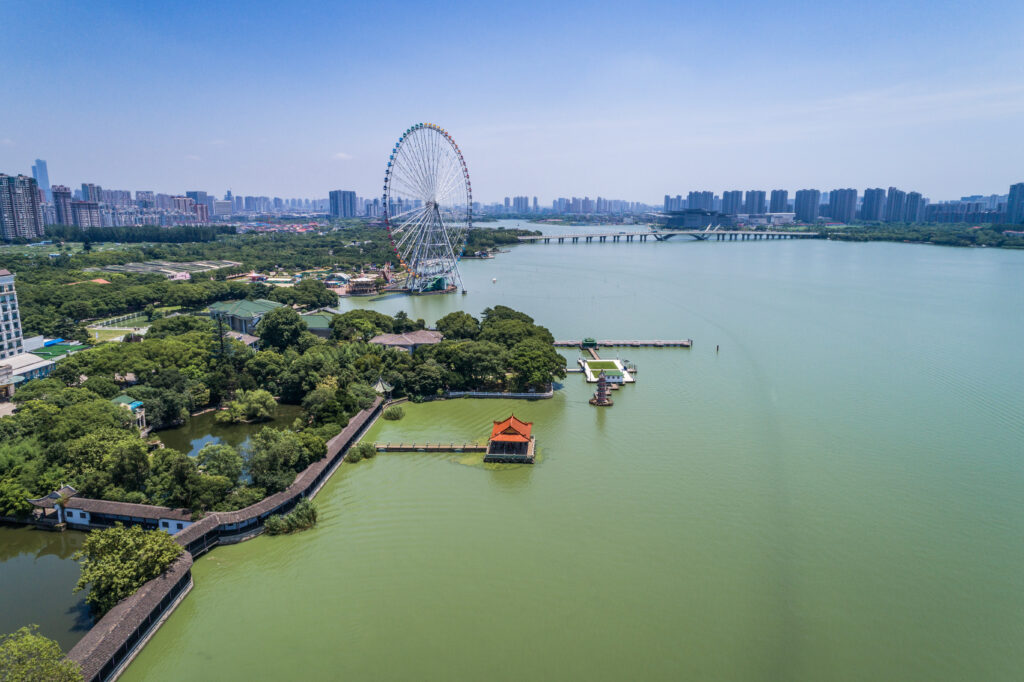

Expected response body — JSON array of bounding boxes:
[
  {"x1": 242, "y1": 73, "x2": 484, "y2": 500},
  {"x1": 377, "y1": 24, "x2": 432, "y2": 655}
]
[{"x1": 75, "y1": 523, "x2": 182, "y2": 617}]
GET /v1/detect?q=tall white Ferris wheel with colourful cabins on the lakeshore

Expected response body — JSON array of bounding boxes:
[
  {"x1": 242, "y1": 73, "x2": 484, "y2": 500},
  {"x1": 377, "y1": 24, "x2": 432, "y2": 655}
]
[{"x1": 383, "y1": 123, "x2": 473, "y2": 293}]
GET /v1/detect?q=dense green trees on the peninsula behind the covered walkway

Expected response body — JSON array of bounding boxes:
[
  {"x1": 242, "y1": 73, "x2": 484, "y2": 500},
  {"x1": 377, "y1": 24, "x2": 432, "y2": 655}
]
[{"x1": 0, "y1": 305, "x2": 565, "y2": 517}]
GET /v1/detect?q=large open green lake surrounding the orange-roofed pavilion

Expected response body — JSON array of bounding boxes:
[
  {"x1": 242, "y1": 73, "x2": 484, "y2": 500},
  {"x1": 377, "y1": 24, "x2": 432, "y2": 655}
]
[{"x1": 25, "y1": 232, "x2": 1024, "y2": 682}]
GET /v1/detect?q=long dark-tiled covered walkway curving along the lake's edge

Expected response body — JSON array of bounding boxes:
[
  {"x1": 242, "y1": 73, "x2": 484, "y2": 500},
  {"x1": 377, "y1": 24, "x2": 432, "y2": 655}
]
[{"x1": 68, "y1": 397, "x2": 384, "y2": 682}]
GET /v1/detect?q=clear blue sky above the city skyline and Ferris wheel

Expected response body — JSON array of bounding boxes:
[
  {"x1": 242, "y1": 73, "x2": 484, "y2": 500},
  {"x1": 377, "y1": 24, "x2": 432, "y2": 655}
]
[{"x1": 0, "y1": 0, "x2": 1024, "y2": 204}]
